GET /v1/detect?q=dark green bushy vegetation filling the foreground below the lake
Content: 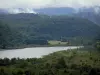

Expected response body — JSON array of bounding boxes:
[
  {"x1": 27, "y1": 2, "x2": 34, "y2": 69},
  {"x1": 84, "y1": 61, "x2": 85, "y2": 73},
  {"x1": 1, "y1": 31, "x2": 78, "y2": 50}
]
[{"x1": 0, "y1": 49, "x2": 100, "y2": 75}]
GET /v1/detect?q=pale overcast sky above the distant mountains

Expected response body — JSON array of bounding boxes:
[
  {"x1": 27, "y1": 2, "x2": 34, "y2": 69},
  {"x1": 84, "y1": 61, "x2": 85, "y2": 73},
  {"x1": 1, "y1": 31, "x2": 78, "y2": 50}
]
[{"x1": 0, "y1": 0, "x2": 100, "y2": 8}]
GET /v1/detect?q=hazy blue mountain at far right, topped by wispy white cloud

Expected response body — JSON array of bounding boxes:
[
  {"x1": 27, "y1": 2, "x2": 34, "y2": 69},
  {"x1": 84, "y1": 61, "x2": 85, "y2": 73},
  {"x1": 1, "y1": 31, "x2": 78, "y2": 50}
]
[{"x1": 75, "y1": 6, "x2": 100, "y2": 26}]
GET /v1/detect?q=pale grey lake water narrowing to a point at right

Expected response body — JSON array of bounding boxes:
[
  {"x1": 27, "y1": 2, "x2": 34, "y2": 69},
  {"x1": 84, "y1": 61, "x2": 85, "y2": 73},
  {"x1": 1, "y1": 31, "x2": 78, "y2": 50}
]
[{"x1": 0, "y1": 46, "x2": 81, "y2": 59}]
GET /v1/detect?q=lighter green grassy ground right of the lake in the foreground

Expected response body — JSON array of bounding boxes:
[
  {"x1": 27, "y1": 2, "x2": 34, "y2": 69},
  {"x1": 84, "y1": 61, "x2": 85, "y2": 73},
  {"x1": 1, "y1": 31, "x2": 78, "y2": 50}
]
[{"x1": 44, "y1": 49, "x2": 100, "y2": 68}]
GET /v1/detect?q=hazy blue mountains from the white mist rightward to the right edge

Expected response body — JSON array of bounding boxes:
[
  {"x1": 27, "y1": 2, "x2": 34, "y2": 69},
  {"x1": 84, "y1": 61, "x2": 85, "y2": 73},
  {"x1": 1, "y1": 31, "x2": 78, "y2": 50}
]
[{"x1": 35, "y1": 6, "x2": 100, "y2": 26}]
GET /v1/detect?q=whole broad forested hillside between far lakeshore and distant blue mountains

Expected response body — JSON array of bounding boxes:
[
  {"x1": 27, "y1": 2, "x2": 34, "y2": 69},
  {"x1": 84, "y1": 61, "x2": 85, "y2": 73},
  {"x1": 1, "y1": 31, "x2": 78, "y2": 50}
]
[{"x1": 0, "y1": 14, "x2": 100, "y2": 48}]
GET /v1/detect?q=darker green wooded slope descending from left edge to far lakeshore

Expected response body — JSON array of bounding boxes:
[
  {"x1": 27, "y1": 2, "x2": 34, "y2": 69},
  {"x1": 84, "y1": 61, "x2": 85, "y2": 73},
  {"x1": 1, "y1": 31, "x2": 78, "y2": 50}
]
[{"x1": 0, "y1": 21, "x2": 48, "y2": 49}]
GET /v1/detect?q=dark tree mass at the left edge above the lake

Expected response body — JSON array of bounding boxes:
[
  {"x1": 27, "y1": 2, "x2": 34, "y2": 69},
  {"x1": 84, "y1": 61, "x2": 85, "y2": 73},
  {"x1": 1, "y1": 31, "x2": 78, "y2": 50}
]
[{"x1": 0, "y1": 22, "x2": 11, "y2": 49}]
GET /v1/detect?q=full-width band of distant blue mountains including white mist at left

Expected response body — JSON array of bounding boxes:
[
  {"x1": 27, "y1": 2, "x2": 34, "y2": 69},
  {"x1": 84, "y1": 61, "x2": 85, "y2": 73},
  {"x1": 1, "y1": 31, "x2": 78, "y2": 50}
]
[{"x1": 0, "y1": 6, "x2": 100, "y2": 26}]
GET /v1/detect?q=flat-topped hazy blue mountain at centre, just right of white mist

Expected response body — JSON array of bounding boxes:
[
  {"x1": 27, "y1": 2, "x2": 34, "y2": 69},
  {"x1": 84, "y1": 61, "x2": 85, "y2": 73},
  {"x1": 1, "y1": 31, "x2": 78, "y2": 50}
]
[{"x1": 35, "y1": 7, "x2": 76, "y2": 15}]
